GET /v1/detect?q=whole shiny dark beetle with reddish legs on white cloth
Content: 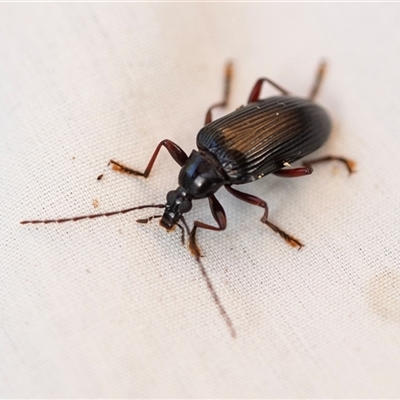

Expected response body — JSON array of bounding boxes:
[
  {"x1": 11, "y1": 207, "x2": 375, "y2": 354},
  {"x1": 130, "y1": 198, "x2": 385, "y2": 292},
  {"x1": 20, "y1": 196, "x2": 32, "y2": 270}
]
[{"x1": 21, "y1": 63, "x2": 354, "y2": 260}]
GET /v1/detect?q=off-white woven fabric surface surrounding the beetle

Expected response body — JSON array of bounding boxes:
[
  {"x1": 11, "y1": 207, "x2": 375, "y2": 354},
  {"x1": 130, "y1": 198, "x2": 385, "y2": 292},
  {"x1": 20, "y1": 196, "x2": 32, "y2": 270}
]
[{"x1": 0, "y1": 3, "x2": 400, "y2": 398}]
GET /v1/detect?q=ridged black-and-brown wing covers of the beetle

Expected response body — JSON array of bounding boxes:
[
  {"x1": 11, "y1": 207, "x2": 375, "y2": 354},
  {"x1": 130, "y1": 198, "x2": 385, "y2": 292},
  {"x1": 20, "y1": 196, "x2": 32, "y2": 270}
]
[{"x1": 197, "y1": 96, "x2": 331, "y2": 184}]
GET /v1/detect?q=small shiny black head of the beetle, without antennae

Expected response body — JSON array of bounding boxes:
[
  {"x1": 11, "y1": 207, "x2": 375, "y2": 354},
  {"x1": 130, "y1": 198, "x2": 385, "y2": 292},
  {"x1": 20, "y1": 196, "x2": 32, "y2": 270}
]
[{"x1": 160, "y1": 187, "x2": 192, "y2": 230}]
